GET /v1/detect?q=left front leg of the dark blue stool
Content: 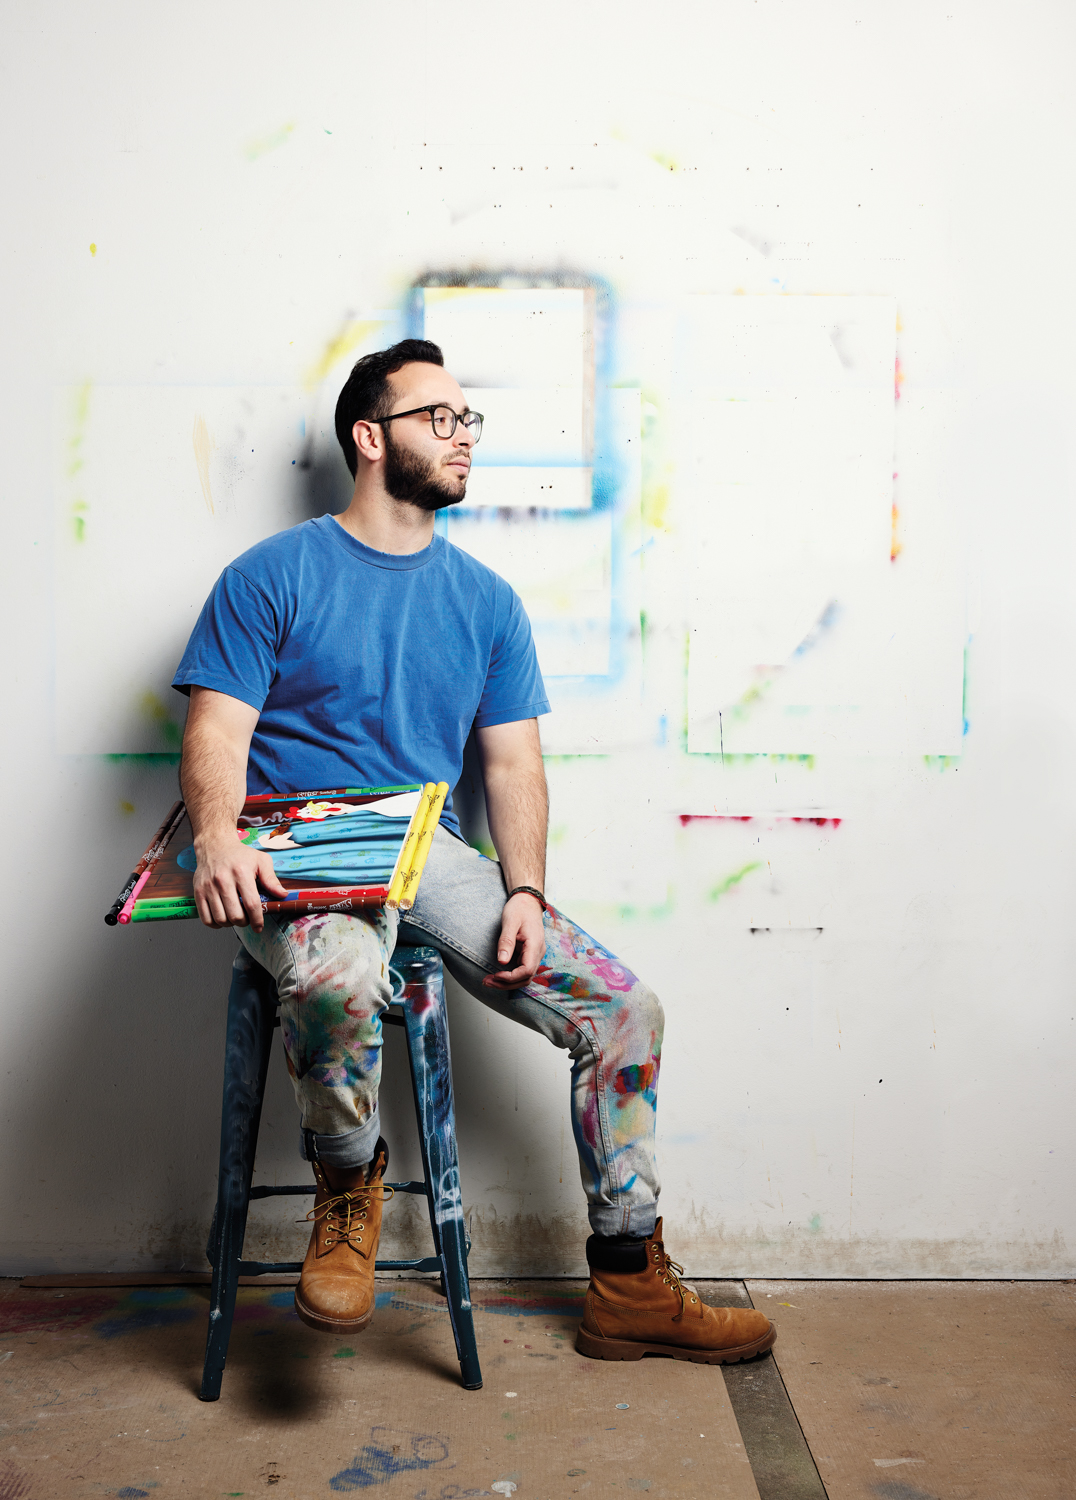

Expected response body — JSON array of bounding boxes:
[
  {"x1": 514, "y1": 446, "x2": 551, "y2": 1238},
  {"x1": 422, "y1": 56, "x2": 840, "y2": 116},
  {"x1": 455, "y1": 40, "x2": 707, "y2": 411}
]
[{"x1": 200, "y1": 953, "x2": 276, "y2": 1401}]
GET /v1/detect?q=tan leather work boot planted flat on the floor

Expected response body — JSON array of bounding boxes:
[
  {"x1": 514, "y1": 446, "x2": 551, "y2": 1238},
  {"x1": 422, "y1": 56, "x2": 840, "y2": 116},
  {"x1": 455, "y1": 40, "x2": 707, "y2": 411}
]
[{"x1": 575, "y1": 1220, "x2": 777, "y2": 1365}]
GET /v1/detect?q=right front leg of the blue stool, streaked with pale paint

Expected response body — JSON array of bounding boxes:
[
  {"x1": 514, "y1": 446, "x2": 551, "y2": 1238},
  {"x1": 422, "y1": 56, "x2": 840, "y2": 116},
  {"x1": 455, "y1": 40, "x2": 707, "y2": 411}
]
[{"x1": 398, "y1": 948, "x2": 482, "y2": 1391}]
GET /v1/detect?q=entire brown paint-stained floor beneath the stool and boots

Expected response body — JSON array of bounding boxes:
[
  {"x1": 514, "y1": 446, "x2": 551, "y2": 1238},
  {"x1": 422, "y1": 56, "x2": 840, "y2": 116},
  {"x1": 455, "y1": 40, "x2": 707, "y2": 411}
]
[{"x1": 8, "y1": 1281, "x2": 1076, "y2": 1500}]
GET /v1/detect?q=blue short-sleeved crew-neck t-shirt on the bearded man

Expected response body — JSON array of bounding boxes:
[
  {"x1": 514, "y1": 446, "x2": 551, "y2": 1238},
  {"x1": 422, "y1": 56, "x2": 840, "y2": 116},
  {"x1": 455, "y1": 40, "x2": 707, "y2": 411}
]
[{"x1": 173, "y1": 516, "x2": 549, "y2": 834}]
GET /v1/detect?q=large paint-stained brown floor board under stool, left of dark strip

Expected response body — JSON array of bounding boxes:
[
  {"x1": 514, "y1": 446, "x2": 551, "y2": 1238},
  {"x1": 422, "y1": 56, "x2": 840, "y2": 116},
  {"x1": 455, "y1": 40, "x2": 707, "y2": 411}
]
[{"x1": 0, "y1": 1281, "x2": 758, "y2": 1500}]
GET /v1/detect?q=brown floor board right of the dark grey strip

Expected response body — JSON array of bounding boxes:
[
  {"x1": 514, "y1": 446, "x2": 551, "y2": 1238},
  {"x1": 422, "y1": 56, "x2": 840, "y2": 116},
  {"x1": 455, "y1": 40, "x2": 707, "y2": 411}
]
[{"x1": 747, "y1": 1281, "x2": 1076, "y2": 1500}]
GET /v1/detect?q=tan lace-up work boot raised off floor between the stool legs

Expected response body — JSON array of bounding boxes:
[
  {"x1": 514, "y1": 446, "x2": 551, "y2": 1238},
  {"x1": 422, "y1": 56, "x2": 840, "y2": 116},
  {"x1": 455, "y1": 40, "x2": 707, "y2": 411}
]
[{"x1": 296, "y1": 1140, "x2": 392, "y2": 1334}]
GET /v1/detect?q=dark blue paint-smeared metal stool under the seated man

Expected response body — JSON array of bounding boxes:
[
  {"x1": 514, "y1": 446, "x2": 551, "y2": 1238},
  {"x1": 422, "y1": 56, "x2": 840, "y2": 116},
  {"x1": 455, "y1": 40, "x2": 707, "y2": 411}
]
[{"x1": 201, "y1": 948, "x2": 482, "y2": 1401}]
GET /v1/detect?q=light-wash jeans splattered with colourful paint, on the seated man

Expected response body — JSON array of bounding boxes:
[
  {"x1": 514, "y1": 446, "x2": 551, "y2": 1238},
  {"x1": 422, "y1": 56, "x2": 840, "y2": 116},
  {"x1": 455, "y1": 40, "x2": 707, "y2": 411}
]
[{"x1": 239, "y1": 830, "x2": 663, "y2": 1235}]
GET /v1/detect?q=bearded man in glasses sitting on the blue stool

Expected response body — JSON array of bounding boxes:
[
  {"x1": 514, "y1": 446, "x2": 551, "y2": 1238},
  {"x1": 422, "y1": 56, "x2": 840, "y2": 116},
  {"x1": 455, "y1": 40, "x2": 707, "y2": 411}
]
[{"x1": 174, "y1": 339, "x2": 774, "y2": 1364}]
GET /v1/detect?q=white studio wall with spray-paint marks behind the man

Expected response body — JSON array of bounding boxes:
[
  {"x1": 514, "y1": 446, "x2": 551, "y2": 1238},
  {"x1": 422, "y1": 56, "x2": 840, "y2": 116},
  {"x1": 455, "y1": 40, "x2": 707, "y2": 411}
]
[{"x1": 0, "y1": 0, "x2": 1076, "y2": 1277}]
